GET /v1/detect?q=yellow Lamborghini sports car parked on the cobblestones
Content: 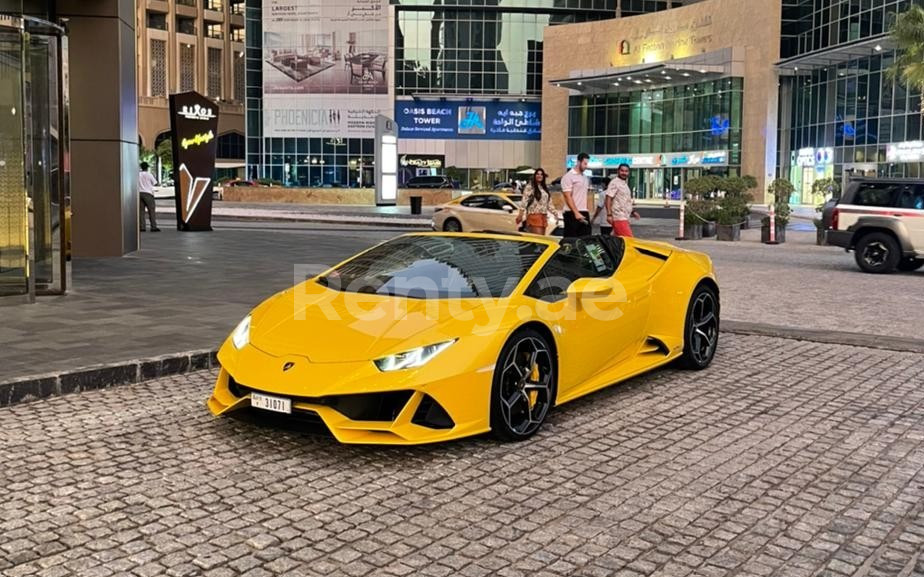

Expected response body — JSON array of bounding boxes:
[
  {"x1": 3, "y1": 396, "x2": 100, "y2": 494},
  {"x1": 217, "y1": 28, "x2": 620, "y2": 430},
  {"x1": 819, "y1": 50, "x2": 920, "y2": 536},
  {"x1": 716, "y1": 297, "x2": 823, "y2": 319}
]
[{"x1": 208, "y1": 233, "x2": 719, "y2": 444}]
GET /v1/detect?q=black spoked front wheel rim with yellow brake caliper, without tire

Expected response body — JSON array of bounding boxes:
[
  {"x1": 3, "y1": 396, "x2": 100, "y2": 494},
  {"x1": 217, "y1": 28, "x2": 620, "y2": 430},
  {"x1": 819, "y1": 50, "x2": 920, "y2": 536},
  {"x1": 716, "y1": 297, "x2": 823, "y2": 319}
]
[{"x1": 500, "y1": 337, "x2": 552, "y2": 435}]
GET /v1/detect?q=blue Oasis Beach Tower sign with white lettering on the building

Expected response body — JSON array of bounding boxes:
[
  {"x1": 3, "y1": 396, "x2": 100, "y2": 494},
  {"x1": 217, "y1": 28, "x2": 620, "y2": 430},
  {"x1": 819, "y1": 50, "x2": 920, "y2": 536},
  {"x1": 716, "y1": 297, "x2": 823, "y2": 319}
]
[{"x1": 395, "y1": 100, "x2": 542, "y2": 140}]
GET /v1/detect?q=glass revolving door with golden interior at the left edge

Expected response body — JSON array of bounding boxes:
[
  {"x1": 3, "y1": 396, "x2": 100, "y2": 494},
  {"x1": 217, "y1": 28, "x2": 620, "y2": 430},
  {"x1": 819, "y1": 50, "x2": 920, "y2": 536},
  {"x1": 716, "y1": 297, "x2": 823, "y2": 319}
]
[{"x1": 0, "y1": 16, "x2": 70, "y2": 300}]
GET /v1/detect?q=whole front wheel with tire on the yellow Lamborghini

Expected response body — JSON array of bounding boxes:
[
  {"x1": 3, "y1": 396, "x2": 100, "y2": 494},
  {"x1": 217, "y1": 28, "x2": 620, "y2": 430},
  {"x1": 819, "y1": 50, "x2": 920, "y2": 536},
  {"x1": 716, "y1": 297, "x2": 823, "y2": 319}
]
[{"x1": 491, "y1": 328, "x2": 558, "y2": 442}]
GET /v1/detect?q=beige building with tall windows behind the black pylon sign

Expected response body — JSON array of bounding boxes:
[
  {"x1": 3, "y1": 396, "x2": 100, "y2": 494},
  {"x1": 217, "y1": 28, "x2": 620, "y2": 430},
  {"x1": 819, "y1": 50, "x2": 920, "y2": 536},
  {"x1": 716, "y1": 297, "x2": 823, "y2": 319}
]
[{"x1": 136, "y1": 0, "x2": 246, "y2": 177}]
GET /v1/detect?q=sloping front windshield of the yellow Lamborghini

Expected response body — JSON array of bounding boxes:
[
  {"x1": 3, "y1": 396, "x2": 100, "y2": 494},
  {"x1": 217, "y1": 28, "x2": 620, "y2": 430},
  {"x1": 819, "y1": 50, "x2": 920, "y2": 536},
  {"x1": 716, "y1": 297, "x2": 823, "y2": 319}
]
[{"x1": 318, "y1": 236, "x2": 546, "y2": 299}]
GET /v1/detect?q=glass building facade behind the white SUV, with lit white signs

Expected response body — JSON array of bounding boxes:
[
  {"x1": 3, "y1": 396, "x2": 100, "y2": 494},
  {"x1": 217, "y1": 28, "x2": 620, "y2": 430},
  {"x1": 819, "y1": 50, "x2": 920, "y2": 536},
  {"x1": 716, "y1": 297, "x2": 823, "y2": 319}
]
[{"x1": 779, "y1": 0, "x2": 924, "y2": 204}]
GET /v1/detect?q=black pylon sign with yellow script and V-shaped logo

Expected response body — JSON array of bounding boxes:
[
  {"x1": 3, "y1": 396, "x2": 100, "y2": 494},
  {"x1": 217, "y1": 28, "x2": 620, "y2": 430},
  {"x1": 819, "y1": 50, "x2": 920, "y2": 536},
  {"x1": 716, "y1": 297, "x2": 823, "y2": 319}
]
[{"x1": 170, "y1": 92, "x2": 218, "y2": 230}]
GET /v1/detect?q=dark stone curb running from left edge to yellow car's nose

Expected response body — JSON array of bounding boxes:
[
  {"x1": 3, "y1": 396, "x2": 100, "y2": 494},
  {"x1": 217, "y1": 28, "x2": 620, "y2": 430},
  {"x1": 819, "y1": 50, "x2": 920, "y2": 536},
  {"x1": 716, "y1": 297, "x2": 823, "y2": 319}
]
[{"x1": 0, "y1": 350, "x2": 218, "y2": 407}]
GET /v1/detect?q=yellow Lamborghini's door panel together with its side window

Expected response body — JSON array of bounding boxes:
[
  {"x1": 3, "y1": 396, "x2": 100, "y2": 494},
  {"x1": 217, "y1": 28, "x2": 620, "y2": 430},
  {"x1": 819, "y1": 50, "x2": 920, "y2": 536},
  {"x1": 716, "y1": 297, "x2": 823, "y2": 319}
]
[{"x1": 525, "y1": 237, "x2": 650, "y2": 401}]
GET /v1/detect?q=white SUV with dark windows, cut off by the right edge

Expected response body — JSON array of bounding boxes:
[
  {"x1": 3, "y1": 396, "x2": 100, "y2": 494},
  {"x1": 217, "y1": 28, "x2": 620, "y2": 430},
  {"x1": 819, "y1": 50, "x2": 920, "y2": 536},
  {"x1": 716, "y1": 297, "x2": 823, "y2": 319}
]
[{"x1": 824, "y1": 178, "x2": 924, "y2": 274}]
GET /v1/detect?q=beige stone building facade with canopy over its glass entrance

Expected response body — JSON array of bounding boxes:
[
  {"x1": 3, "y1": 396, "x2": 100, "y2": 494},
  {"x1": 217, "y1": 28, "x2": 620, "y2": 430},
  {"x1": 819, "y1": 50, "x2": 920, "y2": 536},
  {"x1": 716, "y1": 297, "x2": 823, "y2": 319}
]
[{"x1": 542, "y1": 0, "x2": 782, "y2": 202}]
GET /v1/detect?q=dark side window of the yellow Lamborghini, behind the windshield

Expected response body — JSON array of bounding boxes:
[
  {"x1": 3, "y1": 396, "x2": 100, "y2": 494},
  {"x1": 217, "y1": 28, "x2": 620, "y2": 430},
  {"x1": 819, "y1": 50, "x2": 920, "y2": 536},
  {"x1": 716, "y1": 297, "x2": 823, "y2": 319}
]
[{"x1": 525, "y1": 237, "x2": 624, "y2": 302}]
